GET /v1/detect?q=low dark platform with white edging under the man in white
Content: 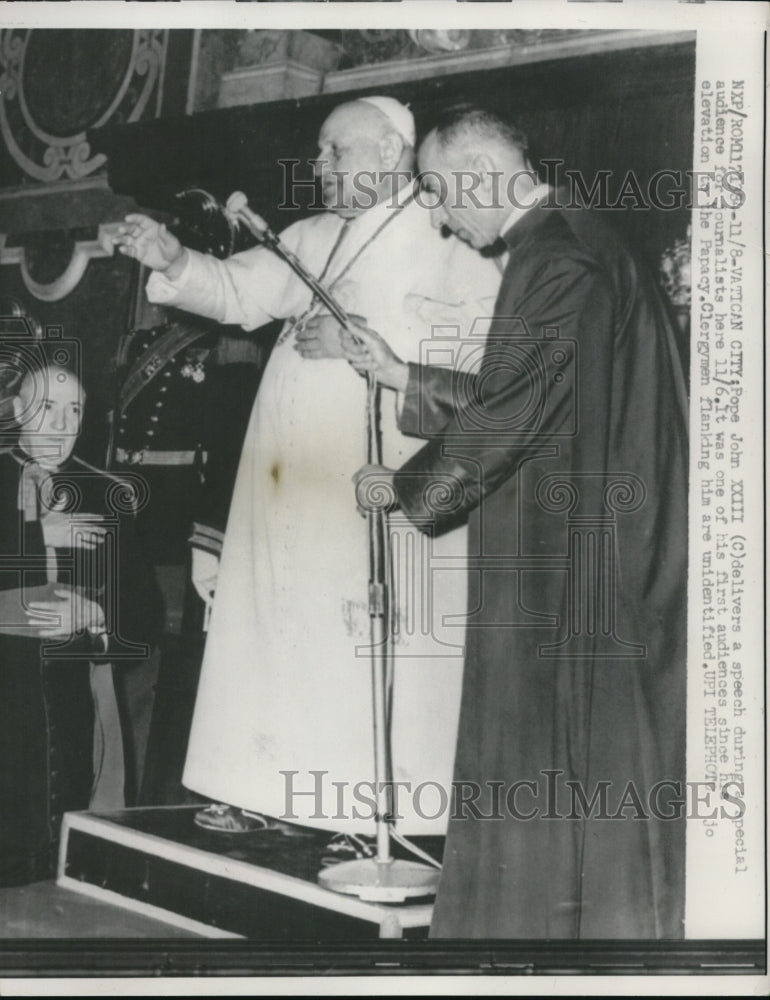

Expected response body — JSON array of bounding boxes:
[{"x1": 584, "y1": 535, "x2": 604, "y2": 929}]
[{"x1": 57, "y1": 806, "x2": 442, "y2": 942}]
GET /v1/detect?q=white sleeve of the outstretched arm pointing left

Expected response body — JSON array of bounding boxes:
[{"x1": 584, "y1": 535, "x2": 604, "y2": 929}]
[{"x1": 147, "y1": 238, "x2": 303, "y2": 330}]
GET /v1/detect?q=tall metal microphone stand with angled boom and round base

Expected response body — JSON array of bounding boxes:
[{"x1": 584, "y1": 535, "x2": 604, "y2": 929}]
[{"x1": 225, "y1": 191, "x2": 439, "y2": 903}]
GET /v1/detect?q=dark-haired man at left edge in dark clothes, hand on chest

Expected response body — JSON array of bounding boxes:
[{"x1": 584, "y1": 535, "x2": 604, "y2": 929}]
[{"x1": 0, "y1": 351, "x2": 158, "y2": 885}]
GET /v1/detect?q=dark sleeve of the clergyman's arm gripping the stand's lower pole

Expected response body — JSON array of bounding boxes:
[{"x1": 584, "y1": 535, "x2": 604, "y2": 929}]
[{"x1": 395, "y1": 251, "x2": 614, "y2": 531}]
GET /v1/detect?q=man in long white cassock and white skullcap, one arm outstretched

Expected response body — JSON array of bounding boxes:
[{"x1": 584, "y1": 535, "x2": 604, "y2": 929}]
[{"x1": 117, "y1": 98, "x2": 500, "y2": 834}]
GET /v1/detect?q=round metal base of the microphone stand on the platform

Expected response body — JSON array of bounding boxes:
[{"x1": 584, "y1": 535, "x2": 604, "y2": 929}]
[{"x1": 318, "y1": 858, "x2": 441, "y2": 903}]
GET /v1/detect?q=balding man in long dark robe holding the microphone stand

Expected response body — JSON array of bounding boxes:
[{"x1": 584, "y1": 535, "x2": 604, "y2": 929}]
[{"x1": 344, "y1": 109, "x2": 688, "y2": 939}]
